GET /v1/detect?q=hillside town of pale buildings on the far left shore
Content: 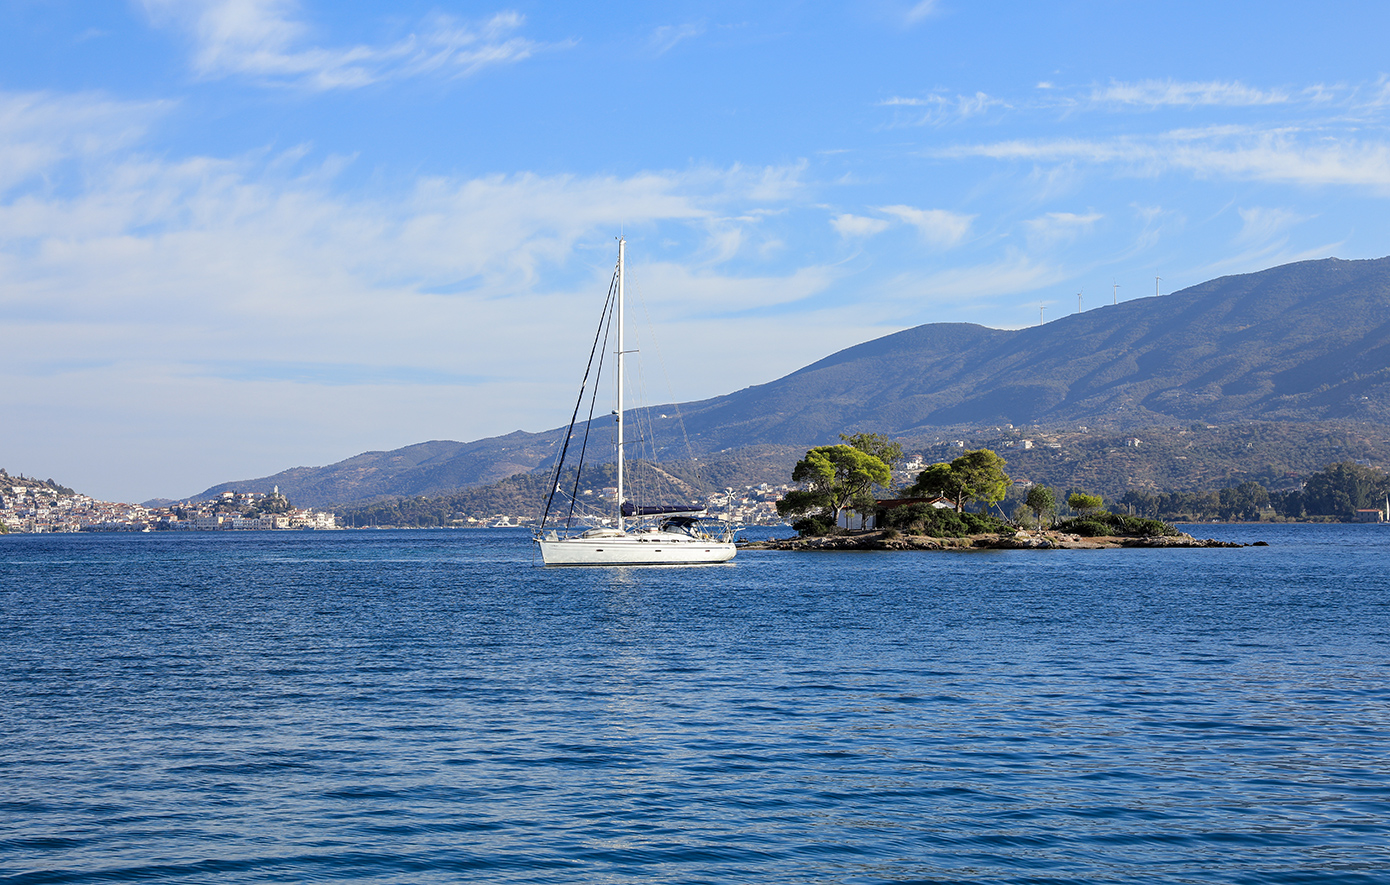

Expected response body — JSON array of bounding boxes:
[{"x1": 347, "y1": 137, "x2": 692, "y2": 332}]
[{"x1": 0, "y1": 468, "x2": 338, "y2": 535}]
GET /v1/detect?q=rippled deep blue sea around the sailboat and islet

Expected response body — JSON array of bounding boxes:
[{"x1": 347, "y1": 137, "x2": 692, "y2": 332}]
[{"x1": 0, "y1": 525, "x2": 1390, "y2": 885}]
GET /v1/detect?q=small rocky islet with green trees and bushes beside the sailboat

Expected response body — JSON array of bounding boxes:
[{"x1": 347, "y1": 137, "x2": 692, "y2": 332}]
[{"x1": 761, "y1": 433, "x2": 1268, "y2": 550}]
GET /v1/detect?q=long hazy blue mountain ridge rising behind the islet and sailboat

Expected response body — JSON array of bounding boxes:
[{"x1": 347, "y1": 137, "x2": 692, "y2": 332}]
[{"x1": 195, "y1": 258, "x2": 1390, "y2": 506}]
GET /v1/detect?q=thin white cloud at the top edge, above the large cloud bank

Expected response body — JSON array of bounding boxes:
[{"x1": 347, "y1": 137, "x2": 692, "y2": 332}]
[{"x1": 143, "y1": 0, "x2": 541, "y2": 90}]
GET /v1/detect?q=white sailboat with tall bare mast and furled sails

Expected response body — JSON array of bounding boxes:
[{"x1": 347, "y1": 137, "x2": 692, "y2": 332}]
[{"x1": 534, "y1": 238, "x2": 735, "y2": 565}]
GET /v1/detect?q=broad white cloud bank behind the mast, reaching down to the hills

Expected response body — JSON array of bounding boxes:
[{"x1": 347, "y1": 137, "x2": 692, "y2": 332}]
[{"x1": 0, "y1": 94, "x2": 845, "y2": 499}]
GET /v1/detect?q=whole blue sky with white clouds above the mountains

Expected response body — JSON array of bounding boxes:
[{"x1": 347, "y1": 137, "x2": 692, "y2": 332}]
[{"x1": 0, "y1": 0, "x2": 1390, "y2": 502}]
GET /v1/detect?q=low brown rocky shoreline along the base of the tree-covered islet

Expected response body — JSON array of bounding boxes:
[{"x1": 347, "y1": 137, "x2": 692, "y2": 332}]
[{"x1": 739, "y1": 529, "x2": 1269, "y2": 550}]
